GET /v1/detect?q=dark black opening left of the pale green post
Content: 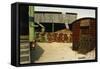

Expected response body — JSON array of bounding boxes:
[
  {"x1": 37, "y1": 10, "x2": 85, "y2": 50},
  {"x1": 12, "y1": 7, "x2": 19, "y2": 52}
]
[{"x1": 19, "y1": 5, "x2": 29, "y2": 35}]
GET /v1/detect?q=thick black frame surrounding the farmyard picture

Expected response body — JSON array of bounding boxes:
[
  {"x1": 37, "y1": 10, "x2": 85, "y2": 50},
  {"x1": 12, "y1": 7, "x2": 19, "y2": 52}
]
[{"x1": 11, "y1": 2, "x2": 98, "y2": 67}]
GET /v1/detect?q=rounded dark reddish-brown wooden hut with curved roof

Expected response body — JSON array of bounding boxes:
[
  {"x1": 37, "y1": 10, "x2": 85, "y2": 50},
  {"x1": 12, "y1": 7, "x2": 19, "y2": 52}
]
[{"x1": 72, "y1": 18, "x2": 96, "y2": 54}]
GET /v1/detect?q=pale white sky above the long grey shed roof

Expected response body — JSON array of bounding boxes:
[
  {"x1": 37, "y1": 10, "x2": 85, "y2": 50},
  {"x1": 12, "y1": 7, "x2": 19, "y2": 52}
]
[{"x1": 35, "y1": 6, "x2": 95, "y2": 19}]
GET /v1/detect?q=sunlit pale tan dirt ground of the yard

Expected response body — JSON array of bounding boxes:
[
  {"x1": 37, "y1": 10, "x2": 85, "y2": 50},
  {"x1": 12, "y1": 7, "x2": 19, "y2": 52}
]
[{"x1": 35, "y1": 42, "x2": 95, "y2": 63}]
